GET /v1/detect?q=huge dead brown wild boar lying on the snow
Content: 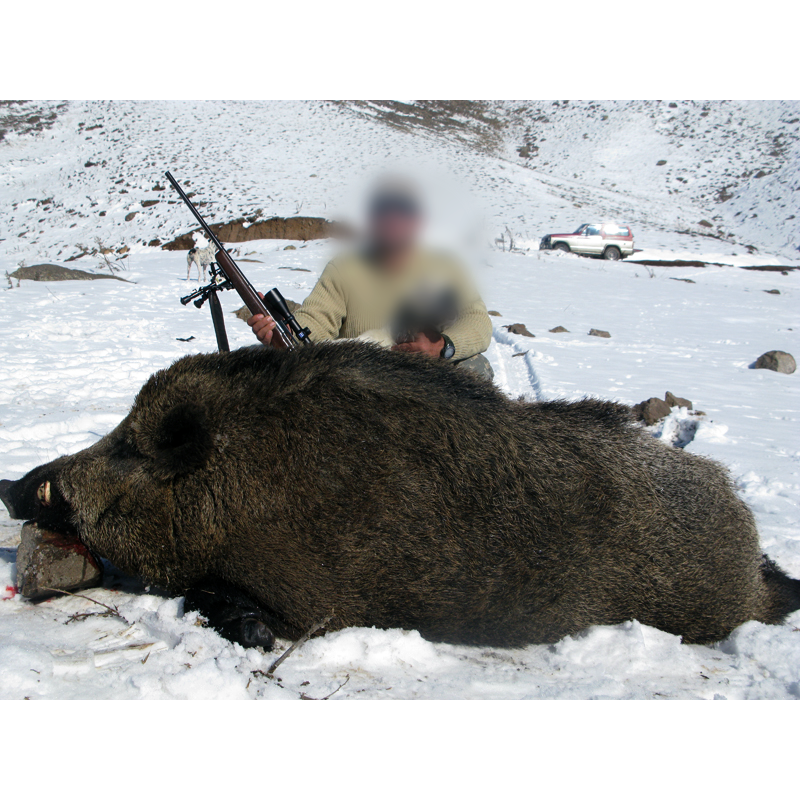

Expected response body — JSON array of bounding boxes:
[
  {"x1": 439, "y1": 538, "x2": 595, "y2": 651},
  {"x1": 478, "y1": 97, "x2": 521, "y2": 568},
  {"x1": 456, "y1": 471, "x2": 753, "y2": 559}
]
[{"x1": 0, "y1": 342, "x2": 800, "y2": 647}]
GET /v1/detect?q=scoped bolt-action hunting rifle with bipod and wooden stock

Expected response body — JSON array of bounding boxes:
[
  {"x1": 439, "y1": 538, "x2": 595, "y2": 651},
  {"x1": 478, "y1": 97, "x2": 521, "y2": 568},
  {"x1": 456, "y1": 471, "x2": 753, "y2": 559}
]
[{"x1": 167, "y1": 172, "x2": 311, "y2": 353}]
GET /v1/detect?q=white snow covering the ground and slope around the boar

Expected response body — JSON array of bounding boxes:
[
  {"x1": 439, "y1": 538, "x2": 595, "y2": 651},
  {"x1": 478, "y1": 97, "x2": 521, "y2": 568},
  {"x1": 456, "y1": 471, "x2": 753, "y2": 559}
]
[{"x1": 0, "y1": 103, "x2": 800, "y2": 700}]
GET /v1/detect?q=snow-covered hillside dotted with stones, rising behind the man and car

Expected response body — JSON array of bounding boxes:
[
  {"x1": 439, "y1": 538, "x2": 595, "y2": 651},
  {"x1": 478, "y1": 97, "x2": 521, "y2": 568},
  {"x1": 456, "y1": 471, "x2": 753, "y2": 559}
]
[{"x1": 0, "y1": 101, "x2": 800, "y2": 264}]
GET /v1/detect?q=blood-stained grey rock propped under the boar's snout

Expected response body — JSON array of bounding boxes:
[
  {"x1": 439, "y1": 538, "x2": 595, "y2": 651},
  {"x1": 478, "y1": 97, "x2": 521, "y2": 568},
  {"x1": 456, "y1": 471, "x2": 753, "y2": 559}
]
[{"x1": 17, "y1": 522, "x2": 103, "y2": 600}]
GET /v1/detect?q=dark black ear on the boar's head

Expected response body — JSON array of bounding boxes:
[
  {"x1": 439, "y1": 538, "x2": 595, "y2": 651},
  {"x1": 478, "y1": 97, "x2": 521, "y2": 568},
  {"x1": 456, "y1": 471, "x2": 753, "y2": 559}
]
[{"x1": 148, "y1": 402, "x2": 214, "y2": 478}]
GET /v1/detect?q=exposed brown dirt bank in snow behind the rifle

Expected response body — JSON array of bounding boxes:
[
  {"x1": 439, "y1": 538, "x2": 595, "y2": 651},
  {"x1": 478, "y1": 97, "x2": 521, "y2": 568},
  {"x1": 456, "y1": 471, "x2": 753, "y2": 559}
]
[{"x1": 161, "y1": 217, "x2": 351, "y2": 250}]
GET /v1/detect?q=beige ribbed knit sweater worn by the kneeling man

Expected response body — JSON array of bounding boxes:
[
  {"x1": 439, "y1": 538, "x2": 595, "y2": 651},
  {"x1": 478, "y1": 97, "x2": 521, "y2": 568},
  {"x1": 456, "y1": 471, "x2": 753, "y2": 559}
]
[{"x1": 295, "y1": 250, "x2": 492, "y2": 359}]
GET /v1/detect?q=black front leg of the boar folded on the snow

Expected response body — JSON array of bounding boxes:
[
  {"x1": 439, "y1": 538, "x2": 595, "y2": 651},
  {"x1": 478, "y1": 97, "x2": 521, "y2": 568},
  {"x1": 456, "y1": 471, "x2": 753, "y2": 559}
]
[{"x1": 183, "y1": 580, "x2": 275, "y2": 651}]
